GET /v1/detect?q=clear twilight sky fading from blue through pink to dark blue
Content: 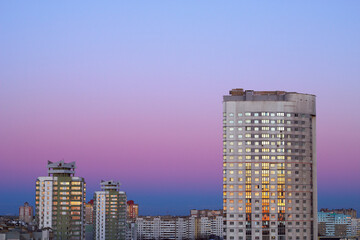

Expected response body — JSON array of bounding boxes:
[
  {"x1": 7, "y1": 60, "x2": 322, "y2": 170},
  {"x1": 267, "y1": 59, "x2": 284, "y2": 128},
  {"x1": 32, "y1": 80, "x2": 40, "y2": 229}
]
[{"x1": 0, "y1": 0, "x2": 360, "y2": 215}]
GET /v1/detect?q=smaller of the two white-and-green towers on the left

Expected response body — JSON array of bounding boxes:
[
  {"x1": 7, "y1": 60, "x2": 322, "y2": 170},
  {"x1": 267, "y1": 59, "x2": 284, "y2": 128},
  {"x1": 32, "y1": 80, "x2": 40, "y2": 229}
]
[{"x1": 94, "y1": 180, "x2": 126, "y2": 240}]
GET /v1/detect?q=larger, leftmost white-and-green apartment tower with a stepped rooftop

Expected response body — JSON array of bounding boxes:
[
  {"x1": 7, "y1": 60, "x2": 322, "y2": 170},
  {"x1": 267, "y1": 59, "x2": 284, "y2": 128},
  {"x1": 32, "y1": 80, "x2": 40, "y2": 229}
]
[{"x1": 35, "y1": 161, "x2": 86, "y2": 240}]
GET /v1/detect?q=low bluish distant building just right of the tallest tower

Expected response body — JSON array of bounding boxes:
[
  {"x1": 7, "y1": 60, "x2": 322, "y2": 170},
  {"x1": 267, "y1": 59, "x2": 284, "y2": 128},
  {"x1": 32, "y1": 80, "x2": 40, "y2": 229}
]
[{"x1": 318, "y1": 212, "x2": 353, "y2": 237}]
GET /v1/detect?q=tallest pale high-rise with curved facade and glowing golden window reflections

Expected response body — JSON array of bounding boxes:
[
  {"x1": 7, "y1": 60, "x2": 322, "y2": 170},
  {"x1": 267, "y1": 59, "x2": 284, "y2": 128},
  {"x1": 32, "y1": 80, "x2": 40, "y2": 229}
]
[{"x1": 223, "y1": 89, "x2": 317, "y2": 240}]
